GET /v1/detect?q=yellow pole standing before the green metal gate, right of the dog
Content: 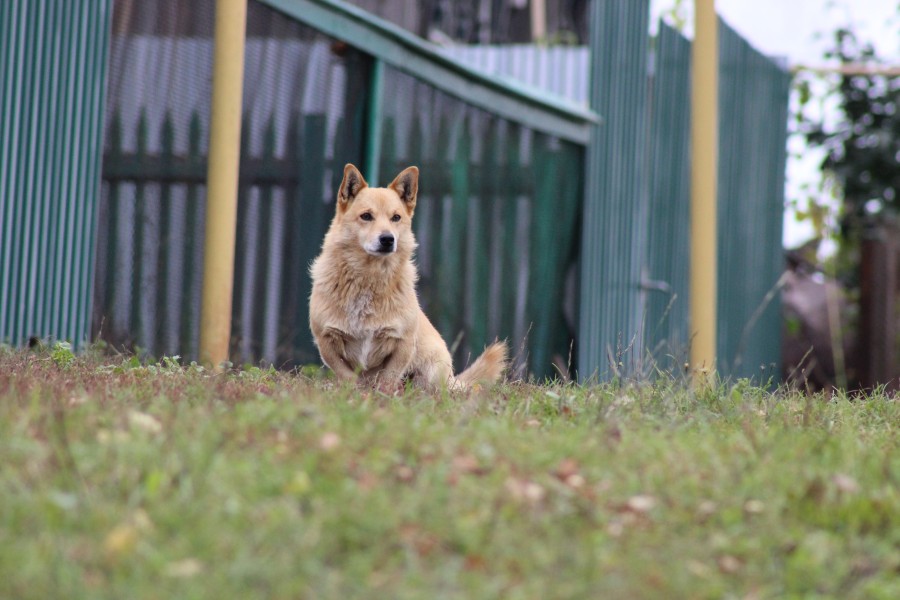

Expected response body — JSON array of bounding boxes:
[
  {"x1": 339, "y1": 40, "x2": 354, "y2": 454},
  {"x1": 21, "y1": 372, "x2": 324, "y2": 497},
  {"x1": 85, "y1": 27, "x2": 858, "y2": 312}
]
[{"x1": 690, "y1": 0, "x2": 719, "y2": 375}]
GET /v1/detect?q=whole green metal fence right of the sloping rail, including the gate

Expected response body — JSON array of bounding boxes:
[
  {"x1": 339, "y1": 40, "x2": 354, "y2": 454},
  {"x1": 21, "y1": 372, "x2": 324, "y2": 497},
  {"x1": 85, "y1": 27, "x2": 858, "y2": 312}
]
[{"x1": 579, "y1": 10, "x2": 790, "y2": 381}]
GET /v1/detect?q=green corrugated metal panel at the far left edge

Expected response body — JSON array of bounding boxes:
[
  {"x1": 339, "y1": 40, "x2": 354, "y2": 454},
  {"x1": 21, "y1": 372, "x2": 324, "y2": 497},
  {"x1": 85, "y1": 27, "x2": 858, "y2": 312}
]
[{"x1": 0, "y1": 0, "x2": 110, "y2": 345}]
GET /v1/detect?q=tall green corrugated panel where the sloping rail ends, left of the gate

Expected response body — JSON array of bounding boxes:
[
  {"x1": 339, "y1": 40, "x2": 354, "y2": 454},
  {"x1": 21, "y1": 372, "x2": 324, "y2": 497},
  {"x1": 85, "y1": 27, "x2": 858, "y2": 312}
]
[{"x1": 578, "y1": 0, "x2": 649, "y2": 378}]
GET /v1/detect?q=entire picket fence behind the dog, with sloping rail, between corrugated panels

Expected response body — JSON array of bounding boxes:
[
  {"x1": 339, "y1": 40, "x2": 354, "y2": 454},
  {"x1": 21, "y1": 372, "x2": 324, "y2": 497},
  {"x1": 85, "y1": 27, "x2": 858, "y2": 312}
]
[{"x1": 94, "y1": 1, "x2": 591, "y2": 375}]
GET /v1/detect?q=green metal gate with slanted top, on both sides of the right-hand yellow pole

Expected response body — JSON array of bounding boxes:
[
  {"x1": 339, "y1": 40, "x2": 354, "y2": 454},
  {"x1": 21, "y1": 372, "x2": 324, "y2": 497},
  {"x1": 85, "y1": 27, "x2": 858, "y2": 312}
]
[{"x1": 645, "y1": 21, "x2": 790, "y2": 381}]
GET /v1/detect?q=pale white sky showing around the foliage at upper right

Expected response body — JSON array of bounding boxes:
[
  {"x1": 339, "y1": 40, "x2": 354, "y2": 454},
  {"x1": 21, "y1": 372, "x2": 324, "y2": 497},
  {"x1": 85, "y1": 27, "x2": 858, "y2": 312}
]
[{"x1": 651, "y1": 0, "x2": 900, "y2": 247}]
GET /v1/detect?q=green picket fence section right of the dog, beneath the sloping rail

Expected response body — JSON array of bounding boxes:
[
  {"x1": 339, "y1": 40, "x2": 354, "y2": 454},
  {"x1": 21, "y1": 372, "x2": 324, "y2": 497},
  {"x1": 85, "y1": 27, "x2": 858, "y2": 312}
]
[{"x1": 379, "y1": 69, "x2": 583, "y2": 377}]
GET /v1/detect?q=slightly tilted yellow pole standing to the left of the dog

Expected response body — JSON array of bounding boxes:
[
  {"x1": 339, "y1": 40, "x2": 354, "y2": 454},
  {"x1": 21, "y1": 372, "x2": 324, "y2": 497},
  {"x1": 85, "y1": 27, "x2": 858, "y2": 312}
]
[{"x1": 200, "y1": 0, "x2": 247, "y2": 368}]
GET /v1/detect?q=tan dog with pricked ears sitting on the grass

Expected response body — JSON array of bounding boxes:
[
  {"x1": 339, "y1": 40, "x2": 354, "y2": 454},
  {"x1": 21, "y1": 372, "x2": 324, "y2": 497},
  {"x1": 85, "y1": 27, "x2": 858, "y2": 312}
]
[{"x1": 309, "y1": 164, "x2": 507, "y2": 389}]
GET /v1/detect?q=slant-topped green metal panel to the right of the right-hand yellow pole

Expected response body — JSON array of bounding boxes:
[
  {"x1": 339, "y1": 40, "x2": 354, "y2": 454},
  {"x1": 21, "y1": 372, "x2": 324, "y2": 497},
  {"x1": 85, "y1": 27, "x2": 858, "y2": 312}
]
[{"x1": 717, "y1": 20, "x2": 790, "y2": 381}]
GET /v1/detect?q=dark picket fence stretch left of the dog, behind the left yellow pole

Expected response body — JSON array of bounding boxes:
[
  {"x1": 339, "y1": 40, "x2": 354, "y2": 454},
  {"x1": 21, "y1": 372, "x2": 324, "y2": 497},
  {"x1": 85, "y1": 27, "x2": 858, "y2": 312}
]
[{"x1": 93, "y1": 14, "x2": 370, "y2": 367}]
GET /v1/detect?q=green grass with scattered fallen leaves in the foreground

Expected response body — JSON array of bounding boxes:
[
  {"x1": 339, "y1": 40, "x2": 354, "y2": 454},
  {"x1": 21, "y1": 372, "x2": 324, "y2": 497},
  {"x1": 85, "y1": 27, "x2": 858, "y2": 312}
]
[{"x1": 0, "y1": 348, "x2": 900, "y2": 599}]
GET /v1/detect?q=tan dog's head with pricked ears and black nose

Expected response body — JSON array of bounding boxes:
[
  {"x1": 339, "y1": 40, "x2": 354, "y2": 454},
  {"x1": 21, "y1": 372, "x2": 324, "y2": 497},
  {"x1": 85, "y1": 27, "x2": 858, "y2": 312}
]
[{"x1": 335, "y1": 164, "x2": 419, "y2": 257}]
